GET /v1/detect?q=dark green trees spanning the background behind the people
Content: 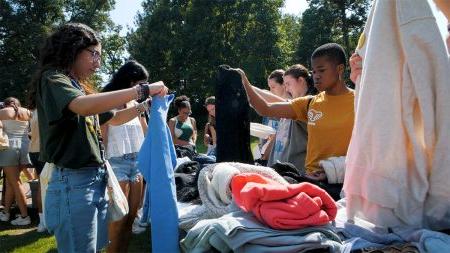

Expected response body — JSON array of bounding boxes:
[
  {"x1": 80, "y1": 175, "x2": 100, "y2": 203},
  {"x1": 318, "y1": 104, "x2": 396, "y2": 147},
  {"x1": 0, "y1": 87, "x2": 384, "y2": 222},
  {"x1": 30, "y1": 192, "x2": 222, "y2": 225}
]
[{"x1": 0, "y1": 0, "x2": 369, "y2": 110}]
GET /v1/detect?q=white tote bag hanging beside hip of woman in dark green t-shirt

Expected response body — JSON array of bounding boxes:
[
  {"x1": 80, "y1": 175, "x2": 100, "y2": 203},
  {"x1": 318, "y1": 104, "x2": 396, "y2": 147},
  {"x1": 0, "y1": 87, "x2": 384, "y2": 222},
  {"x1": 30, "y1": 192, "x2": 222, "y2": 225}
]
[{"x1": 105, "y1": 161, "x2": 129, "y2": 222}]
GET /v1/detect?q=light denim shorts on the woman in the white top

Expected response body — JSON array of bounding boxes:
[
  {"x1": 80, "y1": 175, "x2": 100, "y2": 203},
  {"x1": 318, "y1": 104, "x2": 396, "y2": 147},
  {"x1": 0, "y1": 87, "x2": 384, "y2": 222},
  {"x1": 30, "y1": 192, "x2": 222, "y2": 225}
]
[{"x1": 108, "y1": 153, "x2": 141, "y2": 182}]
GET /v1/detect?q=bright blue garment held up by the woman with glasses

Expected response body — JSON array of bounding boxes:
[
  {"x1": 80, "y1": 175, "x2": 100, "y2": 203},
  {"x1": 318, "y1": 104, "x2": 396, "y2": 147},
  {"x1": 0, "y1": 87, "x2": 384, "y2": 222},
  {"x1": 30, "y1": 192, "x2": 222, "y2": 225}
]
[{"x1": 138, "y1": 95, "x2": 179, "y2": 253}]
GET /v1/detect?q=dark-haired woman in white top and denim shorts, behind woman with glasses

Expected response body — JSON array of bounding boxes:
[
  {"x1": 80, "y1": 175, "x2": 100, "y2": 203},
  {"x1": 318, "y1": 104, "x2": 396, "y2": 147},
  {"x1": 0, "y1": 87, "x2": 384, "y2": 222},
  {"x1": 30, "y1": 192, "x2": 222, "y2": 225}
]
[{"x1": 101, "y1": 61, "x2": 150, "y2": 252}]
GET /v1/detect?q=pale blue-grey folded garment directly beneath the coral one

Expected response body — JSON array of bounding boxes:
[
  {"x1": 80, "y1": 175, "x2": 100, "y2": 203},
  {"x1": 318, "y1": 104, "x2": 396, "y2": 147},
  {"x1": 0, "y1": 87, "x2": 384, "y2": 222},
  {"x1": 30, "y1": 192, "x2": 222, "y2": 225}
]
[{"x1": 181, "y1": 211, "x2": 342, "y2": 253}]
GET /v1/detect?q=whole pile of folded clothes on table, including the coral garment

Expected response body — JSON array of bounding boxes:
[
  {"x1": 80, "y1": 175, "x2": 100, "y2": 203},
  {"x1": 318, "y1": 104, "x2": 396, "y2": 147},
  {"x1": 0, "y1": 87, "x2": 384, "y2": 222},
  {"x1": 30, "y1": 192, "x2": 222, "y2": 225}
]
[{"x1": 175, "y1": 161, "x2": 450, "y2": 253}]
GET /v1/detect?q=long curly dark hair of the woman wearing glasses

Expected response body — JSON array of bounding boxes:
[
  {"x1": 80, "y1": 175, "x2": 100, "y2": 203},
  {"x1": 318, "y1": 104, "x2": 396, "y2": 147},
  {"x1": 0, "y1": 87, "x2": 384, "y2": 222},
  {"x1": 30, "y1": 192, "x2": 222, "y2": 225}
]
[{"x1": 28, "y1": 23, "x2": 100, "y2": 108}]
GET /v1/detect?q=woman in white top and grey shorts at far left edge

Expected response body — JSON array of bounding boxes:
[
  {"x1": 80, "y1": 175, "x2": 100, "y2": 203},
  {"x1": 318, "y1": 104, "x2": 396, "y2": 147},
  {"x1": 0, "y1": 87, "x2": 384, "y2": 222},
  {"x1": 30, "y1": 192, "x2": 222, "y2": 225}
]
[{"x1": 0, "y1": 97, "x2": 31, "y2": 226}]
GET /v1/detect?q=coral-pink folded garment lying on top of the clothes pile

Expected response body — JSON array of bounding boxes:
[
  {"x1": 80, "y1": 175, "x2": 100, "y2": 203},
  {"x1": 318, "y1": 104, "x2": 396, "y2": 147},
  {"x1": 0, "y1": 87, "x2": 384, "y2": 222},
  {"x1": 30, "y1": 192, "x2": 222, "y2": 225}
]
[{"x1": 231, "y1": 173, "x2": 337, "y2": 229}]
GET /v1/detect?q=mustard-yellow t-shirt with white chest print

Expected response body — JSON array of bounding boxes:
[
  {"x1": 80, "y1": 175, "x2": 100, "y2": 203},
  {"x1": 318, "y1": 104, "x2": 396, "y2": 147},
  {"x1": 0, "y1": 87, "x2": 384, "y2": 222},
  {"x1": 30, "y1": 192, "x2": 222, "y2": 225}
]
[{"x1": 291, "y1": 90, "x2": 355, "y2": 174}]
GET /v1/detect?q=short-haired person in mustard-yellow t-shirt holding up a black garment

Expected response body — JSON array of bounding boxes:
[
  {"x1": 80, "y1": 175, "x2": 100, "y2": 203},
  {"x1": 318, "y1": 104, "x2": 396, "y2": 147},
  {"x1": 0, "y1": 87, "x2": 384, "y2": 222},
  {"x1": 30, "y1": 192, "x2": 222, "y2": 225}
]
[{"x1": 239, "y1": 43, "x2": 354, "y2": 184}]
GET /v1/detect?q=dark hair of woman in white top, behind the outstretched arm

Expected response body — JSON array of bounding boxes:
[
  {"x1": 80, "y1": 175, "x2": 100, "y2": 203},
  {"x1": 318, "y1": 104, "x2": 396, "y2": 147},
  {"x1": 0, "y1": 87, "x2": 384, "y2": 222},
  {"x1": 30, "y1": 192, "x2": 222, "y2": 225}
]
[{"x1": 102, "y1": 60, "x2": 148, "y2": 92}]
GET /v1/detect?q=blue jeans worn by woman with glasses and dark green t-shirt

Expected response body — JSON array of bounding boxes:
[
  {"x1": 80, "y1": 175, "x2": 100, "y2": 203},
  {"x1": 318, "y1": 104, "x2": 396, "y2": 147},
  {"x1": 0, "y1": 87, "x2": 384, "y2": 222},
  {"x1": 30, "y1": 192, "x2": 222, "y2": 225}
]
[{"x1": 45, "y1": 167, "x2": 108, "y2": 252}]
